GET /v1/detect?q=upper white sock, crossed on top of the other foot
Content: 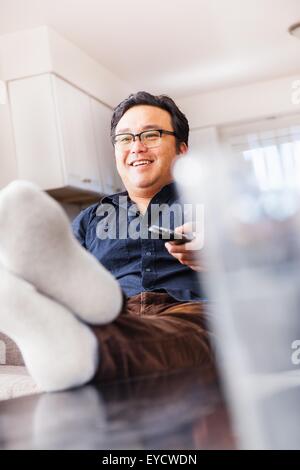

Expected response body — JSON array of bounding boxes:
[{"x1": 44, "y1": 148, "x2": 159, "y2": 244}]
[{"x1": 0, "y1": 181, "x2": 122, "y2": 324}]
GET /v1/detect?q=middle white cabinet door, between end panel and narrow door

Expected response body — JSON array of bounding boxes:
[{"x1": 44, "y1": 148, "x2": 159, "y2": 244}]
[{"x1": 52, "y1": 76, "x2": 103, "y2": 193}]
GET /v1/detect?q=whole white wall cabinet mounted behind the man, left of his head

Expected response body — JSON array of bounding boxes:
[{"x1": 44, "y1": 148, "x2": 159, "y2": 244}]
[{"x1": 9, "y1": 74, "x2": 120, "y2": 194}]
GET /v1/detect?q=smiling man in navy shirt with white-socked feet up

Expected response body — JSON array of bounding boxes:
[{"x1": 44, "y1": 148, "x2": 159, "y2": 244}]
[{"x1": 0, "y1": 92, "x2": 214, "y2": 390}]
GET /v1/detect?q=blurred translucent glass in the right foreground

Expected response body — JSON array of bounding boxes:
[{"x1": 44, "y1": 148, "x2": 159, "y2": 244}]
[{"x1": 174, "y1": 125, "x2": 300, "y2": 449}]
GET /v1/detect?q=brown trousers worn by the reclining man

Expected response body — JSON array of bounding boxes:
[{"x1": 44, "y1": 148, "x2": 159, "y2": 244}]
[{"x1": 91, "y1": 292, "x2": 216, "y2": 382}]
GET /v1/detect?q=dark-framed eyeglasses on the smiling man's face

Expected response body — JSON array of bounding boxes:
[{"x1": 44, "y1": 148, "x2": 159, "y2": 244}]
[{"x1": 112, "y1": 129, "x2": 176, "y2": 150}]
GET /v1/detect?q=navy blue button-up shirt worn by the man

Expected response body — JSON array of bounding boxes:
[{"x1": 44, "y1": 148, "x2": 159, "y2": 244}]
[{"x1": 72, "y1": 183, "x2": 204, "y2": 301}]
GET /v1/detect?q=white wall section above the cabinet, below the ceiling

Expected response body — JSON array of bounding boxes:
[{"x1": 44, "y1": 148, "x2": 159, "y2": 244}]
[{"x1": 0, "y1": 26, "x2": 131, "y2": 108}]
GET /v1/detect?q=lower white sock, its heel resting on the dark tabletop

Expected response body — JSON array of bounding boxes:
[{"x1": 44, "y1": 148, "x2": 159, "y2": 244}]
[{"x1": 0, "y1": 266, "x2": 99, "y2": 391}]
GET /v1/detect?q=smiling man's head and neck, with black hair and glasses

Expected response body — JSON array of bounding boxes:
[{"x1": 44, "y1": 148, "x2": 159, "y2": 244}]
[{"x1": 112, "y1": 103, "x2": 188, "y2": 213}]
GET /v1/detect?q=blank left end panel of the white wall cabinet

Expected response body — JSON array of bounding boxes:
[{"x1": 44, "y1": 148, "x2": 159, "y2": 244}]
[{"x1": 9, "y1": 74, "x2": 64, "y2": 189}]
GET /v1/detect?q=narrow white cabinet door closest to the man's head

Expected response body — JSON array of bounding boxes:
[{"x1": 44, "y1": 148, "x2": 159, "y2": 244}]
[{"x1": 90, "y1": 98, "x2": 124, "y2": 194}]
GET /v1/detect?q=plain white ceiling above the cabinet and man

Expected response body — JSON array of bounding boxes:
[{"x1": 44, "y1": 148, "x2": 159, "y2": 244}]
[{"x1": 0, "y1": 0, "x2": 300, "y2": 98}]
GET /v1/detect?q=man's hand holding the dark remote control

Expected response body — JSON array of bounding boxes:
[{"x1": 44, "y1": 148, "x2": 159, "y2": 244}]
[{"x1": 165, "y1": 222, "x2": 207, "y2": 272}]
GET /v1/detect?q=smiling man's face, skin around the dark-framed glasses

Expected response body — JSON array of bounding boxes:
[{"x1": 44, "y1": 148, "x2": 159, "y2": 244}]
[{"x1": 115, "y1": 105, "x2": 186, "y2": 195}]
